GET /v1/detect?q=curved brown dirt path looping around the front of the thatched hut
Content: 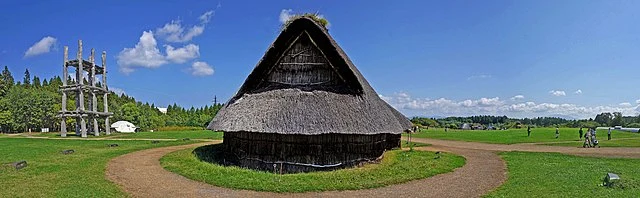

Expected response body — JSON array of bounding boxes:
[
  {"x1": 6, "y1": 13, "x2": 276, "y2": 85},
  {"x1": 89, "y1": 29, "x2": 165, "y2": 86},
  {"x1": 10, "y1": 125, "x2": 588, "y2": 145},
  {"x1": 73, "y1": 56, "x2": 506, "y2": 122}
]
[{"x1": 106, "y1": 141, "x2": 506, "y2": 197}]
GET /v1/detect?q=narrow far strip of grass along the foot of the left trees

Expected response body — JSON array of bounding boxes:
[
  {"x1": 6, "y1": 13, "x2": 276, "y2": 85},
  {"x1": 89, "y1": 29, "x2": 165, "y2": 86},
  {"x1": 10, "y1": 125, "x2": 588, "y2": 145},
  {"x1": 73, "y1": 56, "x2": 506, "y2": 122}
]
[{"x1": 32, "y1": 130, "x2": 222, "y2": 140}]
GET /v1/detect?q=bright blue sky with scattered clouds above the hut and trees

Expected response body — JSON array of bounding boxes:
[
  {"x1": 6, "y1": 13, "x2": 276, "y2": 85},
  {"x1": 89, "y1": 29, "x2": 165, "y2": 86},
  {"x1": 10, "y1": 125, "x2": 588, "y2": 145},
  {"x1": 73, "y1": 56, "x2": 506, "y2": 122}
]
[{"x1": 0, "y1": 0, "x2": 640, "y2": 118}]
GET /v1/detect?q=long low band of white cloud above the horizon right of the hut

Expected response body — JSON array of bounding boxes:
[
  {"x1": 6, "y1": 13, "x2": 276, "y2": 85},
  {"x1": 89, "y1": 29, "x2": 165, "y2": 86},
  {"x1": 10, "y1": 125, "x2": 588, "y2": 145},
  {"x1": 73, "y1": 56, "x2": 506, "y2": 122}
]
[{"x1": 380, "y1": 93, "x2": 640, "y2": 119}]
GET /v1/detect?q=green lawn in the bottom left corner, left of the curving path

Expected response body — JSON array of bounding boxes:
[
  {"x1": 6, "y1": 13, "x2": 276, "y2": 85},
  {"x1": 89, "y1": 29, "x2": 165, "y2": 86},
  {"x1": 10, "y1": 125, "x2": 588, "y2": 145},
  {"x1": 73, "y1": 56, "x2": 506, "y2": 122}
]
[{"x1": 0, "y1": 138, "x2": 196, "y2": 197}]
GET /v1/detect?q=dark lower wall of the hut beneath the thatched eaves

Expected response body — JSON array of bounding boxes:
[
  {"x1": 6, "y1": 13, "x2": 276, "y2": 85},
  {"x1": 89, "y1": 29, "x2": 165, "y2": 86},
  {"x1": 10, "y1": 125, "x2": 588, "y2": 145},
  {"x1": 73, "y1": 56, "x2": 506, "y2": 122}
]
[{"x1": 223, "y1": 132, "x2": 400, "y2": 173}]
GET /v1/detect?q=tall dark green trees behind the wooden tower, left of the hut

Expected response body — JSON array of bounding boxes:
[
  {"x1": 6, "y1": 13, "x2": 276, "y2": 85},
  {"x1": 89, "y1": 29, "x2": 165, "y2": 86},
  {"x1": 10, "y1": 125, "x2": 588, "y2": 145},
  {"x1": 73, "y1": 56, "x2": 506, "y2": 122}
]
[{"x1": 0, "y1": 66, "x2": 222, "y2": 133}]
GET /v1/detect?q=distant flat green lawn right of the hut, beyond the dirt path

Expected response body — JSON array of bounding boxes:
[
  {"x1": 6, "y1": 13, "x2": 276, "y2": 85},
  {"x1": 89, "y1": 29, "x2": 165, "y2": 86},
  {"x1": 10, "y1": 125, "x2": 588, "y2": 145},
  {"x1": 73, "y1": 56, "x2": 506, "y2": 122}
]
[{"x1": 413, "y1": 128, "x2": 640, "y2": 146}]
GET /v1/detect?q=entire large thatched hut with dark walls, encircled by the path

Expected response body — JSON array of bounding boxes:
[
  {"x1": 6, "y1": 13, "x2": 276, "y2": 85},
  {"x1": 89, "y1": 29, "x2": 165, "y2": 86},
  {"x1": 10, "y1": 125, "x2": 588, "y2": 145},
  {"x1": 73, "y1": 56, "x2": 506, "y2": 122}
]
[{"x1": 208, "y1": 16, "x2": 411, "y2": 173}]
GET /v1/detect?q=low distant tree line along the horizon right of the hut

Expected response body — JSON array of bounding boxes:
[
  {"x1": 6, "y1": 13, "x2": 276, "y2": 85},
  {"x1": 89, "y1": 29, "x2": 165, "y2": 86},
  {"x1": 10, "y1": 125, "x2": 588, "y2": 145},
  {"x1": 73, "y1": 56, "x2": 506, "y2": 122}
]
[{"x1": 411, "y1": 112, "x2": 640, "y2": 129}]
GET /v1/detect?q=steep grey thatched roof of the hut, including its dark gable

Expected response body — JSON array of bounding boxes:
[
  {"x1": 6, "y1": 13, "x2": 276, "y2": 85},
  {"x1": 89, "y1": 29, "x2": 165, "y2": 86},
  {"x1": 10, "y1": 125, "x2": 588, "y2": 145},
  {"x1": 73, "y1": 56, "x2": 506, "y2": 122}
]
[{"x1": 208, "y1": 17, "x2": 411, "y2": 135}]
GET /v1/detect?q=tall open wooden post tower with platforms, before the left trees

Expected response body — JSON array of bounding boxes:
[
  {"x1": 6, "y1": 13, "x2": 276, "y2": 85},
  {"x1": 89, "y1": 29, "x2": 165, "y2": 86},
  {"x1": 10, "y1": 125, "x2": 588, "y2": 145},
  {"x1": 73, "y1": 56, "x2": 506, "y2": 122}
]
[{"x1": 58, "y1": 40, "x2": 113, "y2": 137}]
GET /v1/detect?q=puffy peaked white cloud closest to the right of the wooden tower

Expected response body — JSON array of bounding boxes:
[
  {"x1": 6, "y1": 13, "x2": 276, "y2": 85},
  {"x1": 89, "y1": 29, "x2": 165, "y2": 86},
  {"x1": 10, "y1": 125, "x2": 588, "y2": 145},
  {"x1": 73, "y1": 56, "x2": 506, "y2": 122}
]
[{"x1": 117, "y1": 31, "x2": 167, "y2": 74}]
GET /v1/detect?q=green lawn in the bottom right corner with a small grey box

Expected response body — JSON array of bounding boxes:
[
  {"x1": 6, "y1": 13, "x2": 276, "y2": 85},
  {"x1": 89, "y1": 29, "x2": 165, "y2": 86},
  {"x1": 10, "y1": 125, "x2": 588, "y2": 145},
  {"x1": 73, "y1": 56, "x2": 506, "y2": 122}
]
[{"x1": 485, "y1": 152, "x2": 640, "y2": 197}]
